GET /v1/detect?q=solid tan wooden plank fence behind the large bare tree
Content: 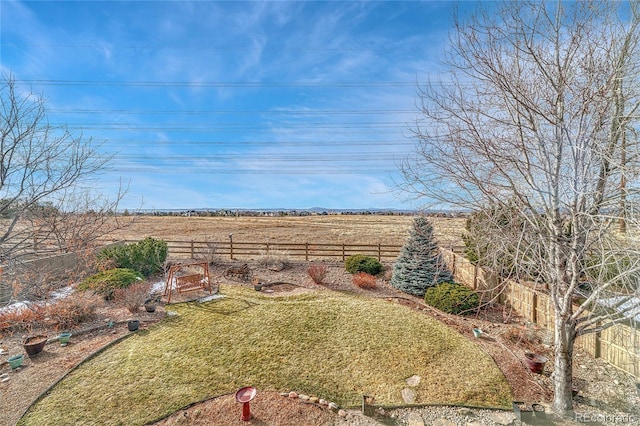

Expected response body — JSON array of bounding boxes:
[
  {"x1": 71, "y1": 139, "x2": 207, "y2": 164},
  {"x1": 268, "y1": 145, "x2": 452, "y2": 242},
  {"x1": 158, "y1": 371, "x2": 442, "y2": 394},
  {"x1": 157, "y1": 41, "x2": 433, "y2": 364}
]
[{"x1": 443, "y1": 250, "x2": 640, "y2": 378}]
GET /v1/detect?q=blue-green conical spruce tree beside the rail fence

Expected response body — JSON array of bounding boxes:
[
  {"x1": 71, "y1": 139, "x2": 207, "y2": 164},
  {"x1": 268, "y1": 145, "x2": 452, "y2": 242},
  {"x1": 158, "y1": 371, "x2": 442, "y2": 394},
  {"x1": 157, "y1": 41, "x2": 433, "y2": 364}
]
[{"x1": 391, "y1": 216, "x2": 453, "y2": 297}]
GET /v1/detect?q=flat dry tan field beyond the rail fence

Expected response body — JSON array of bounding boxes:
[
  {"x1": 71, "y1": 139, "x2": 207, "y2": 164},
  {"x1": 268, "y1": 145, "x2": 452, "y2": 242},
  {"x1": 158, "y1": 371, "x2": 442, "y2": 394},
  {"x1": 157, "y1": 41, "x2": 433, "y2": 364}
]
[{"x1": 104, "y1": 215, "x2": 464, "y2": 247}]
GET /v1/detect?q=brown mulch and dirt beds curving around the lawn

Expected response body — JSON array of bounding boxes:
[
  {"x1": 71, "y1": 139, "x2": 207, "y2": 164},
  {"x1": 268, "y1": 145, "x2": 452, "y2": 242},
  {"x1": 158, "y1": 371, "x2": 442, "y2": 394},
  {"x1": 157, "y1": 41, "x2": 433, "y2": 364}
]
[{"x1": 0, "y1": 262, "x2": 640, "y2": 425}]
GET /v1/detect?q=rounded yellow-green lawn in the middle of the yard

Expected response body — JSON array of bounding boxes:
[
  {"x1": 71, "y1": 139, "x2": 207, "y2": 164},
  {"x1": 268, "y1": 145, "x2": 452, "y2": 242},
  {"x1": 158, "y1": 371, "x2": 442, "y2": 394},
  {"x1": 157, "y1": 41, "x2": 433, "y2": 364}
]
[{"x1": 19, "y1": 287, "x2": 512, "y2": 425}]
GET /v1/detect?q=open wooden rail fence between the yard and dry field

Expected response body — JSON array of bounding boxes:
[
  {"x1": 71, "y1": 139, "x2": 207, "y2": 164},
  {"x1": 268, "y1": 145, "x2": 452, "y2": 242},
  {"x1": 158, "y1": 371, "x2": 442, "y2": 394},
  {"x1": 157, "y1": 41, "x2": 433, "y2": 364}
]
[{"x1": 120, "y1": 240, "x2": 402, "y2": 261}]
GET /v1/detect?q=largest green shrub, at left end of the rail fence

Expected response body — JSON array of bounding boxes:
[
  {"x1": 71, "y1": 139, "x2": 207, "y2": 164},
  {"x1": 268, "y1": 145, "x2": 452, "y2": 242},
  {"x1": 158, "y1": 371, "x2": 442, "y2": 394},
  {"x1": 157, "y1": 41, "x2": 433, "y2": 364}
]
[{"x1": 98, "y1": 237, "x2": 169, "y2": 277}]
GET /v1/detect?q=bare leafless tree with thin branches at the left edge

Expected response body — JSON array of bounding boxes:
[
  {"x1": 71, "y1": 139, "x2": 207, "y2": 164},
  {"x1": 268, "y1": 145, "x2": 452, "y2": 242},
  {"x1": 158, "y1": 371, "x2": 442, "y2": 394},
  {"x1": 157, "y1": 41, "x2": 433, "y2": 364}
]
[{"x1": 0, "y1": 76, "x2": 132, "y2": 302}]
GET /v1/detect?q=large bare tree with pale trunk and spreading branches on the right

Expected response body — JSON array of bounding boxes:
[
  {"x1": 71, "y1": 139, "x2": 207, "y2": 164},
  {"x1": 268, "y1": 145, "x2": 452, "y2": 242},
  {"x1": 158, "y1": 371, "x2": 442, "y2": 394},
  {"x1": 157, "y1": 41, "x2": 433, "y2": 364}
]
[{"x1": 402, "y1": 1, "x2": 640, "y2": 413}]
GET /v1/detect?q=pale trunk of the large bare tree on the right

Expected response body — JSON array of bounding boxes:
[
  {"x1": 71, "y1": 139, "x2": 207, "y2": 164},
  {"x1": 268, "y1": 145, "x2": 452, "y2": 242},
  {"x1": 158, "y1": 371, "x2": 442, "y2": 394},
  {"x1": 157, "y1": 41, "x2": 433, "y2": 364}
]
[{"x1": 553, "y1": 318, "x2": 575, "y2": 416}]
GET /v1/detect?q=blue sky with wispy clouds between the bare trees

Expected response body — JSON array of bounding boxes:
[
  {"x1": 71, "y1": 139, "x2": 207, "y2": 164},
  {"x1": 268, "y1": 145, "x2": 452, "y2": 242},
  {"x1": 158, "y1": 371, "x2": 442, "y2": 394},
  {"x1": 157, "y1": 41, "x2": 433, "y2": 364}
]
[{"x1": 0, "y1": 0, "x2": 460, "y2": 209}]
